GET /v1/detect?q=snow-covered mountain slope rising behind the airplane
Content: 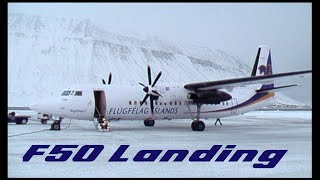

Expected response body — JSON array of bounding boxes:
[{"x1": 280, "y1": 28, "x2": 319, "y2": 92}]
[{"x1": 8, "y1": 14, "x2": 302, "y2": 106}]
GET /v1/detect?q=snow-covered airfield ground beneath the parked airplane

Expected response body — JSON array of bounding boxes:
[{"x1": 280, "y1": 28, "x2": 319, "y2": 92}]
[{"x1": 8, "y1": 111, "x2": 312, "y2": 177}]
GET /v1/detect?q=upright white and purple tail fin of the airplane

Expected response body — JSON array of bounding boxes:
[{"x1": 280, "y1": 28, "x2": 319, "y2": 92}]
[{"x1": 251, "y1": 45, "x2": 274, "y2": 90}]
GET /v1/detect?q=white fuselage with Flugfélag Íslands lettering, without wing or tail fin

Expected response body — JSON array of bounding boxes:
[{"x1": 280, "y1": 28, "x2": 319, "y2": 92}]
[{"x1": 32, "y1": 84, "x2": 274, "y2": 120}]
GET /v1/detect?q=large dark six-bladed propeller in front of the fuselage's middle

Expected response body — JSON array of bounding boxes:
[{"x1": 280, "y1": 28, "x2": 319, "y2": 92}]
[{"x1": 139, "y1": 65, "x2": 162, "y2": 116}]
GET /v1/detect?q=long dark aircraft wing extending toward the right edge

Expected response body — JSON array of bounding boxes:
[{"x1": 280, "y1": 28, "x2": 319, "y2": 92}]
[{"x1": 184, "y1": 70, "x2": 312, "y2": 91}]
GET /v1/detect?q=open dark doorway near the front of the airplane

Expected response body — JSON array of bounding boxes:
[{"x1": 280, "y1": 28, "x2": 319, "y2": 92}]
[{"x1": 93, "y1": 90, "x2": 107, "y2": 118}]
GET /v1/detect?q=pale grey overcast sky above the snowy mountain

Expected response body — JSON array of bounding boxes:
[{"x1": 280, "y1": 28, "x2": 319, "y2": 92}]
[{"x1": 8, "y1": 3, "x2": 312, "y2": 105}]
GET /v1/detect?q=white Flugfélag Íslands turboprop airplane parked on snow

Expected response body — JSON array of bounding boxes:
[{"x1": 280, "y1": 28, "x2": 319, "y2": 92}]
[{"x1": 30, "y1": 45, "x2": 312, "y2": 131}]
